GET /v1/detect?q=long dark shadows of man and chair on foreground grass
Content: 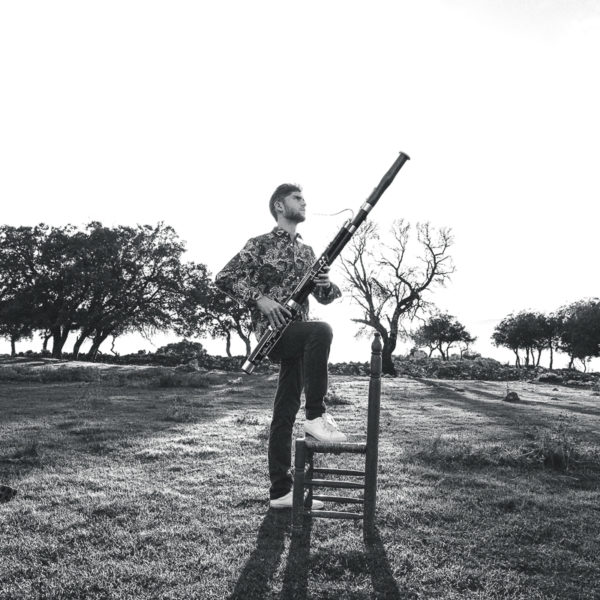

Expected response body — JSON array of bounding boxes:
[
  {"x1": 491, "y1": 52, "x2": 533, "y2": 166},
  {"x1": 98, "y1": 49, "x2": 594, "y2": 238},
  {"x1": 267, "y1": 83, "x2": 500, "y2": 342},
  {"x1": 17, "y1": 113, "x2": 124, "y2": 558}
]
[{"x1": 229, "y1": 509, "x2": 408, "y2": 600}]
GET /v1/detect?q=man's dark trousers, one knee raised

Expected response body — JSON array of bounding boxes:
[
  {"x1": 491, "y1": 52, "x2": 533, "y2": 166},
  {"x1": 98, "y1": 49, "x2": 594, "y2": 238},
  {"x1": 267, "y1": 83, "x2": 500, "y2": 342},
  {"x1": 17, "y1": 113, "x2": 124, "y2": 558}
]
[{"x1": 269, "y1": 321, "x2": 333, "y2": 500}]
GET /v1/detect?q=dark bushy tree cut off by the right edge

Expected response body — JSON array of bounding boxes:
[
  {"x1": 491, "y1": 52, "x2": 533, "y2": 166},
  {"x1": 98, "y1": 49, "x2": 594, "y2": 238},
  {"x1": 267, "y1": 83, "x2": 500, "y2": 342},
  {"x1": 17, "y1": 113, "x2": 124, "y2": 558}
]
[{"x1": 557, "y1": 298, "x2": 600, "y2": 371}]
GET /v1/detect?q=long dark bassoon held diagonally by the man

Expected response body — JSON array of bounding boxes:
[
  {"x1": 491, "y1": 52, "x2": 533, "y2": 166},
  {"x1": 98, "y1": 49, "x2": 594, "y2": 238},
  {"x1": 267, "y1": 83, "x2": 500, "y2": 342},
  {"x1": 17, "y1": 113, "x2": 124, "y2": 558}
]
[{"x1": 242, "y1": 152, "x2": 410, "y2": 374}]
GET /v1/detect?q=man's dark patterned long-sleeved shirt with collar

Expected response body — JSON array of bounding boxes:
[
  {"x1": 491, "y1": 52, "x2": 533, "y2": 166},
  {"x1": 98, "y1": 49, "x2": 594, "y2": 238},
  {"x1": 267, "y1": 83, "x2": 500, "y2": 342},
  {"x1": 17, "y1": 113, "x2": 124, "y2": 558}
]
[{"x1": 215, "y1": 226, "x2": 342, "y2": 338}]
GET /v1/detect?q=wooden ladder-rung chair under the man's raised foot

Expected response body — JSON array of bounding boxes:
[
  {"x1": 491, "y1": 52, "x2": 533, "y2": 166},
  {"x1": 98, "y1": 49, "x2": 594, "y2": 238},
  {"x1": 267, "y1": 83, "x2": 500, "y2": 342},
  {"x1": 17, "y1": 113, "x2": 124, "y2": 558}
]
[{"x1": 292, "y1": 333, "x2": 383, "y2": 540}]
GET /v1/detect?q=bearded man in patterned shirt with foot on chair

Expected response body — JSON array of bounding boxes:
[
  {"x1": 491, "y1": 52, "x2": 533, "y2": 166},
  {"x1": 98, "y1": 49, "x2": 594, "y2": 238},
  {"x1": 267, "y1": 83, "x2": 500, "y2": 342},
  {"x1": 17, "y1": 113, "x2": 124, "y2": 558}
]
[{"x1": 215, "y1": 183, "x2": 346, "y2": 509}]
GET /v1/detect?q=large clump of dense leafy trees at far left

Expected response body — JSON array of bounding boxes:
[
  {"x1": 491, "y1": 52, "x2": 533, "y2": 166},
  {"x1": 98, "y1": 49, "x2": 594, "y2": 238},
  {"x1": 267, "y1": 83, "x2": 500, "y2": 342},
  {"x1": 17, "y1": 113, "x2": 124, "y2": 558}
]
[{"x1": 0, "y1": 222, "x2": 211, "y2": 358}]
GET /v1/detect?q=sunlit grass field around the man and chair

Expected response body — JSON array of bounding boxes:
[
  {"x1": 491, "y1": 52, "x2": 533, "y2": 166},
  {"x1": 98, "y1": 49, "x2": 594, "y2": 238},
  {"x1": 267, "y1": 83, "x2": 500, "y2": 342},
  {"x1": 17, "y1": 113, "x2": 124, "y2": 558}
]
[{"x1": 0, "y1": 373, "x2": 600, "y2": 600}]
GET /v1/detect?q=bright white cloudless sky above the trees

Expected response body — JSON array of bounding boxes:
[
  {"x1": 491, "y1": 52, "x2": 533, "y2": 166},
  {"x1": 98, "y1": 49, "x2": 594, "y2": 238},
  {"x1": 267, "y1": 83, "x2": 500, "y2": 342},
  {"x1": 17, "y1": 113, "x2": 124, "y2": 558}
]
[{"x1": 0, "y1": 0, "x2": 600, "y2": 368}]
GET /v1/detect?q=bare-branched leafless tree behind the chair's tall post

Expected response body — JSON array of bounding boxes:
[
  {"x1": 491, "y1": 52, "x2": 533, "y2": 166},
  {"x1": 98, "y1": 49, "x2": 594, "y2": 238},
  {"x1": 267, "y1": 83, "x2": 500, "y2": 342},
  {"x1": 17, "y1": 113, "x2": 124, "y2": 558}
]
[{"x1": 341, "y1": 220, "x2": 454, "y2": 375}]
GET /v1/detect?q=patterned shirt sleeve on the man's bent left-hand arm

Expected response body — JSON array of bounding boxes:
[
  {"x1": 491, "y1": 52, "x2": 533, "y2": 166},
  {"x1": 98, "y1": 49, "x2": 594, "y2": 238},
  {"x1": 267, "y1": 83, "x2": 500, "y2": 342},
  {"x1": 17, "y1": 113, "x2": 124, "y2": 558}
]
[{"x1": 215, "y1": 239, "x2": 262, "y2": 308}]
